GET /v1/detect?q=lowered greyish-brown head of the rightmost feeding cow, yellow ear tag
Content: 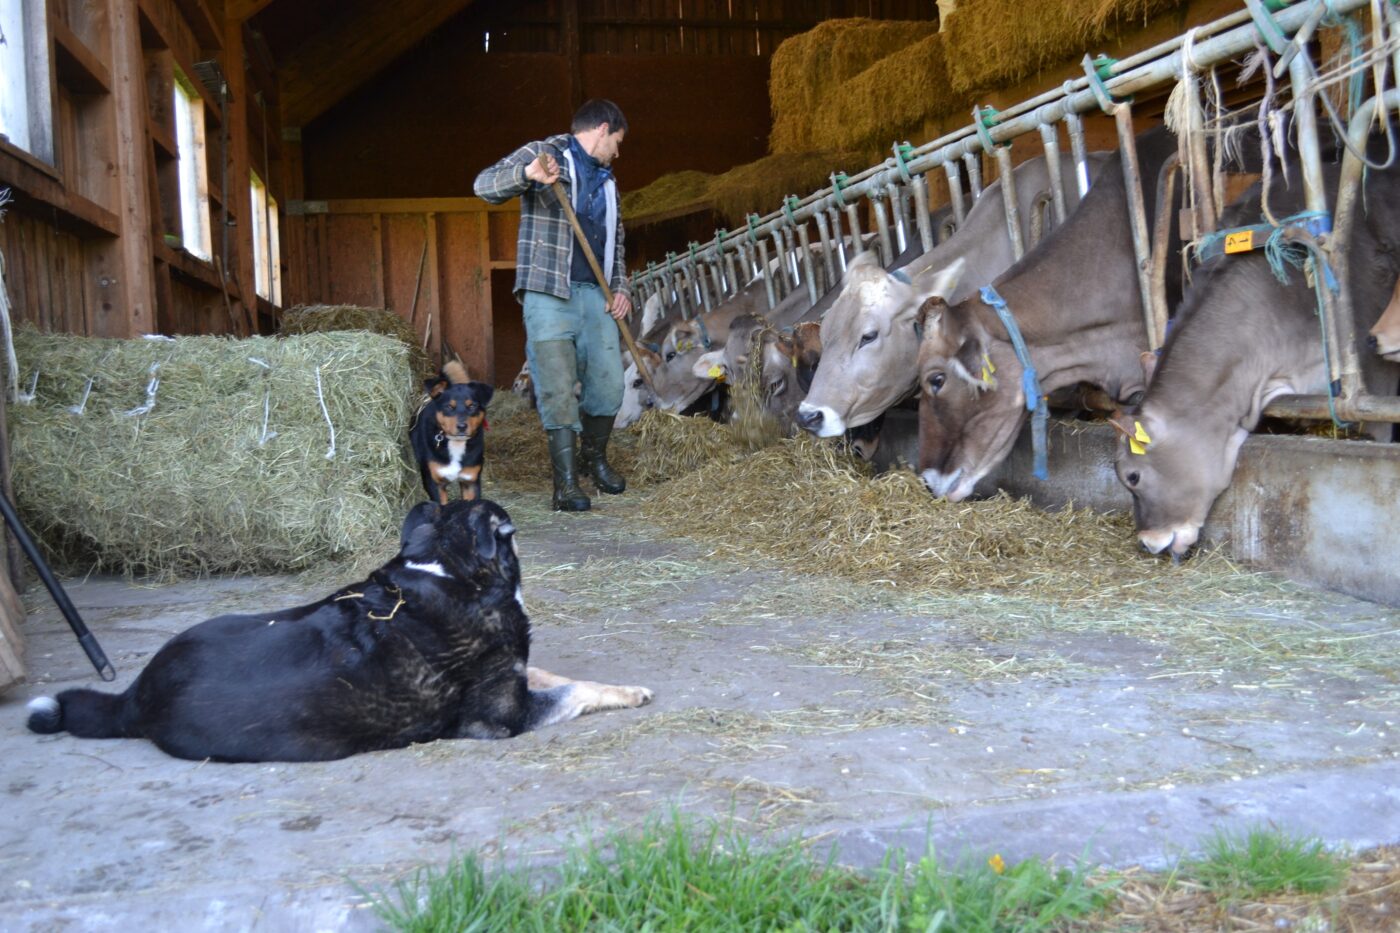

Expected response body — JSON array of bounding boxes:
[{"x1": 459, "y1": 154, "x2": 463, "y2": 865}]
[{"x1": 1110, "y1": 398, "x2": 1249, "y2": 558}]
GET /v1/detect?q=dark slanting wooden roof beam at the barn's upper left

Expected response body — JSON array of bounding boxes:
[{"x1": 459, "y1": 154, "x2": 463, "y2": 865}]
[{"x1": 277, "y1": 0, "x2": 472, "y2": 126}]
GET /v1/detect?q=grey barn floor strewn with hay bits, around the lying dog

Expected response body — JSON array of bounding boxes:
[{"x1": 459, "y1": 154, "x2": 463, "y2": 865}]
[{"x1": 0, "y1": 481, "x2": 1400, "y2": 930}]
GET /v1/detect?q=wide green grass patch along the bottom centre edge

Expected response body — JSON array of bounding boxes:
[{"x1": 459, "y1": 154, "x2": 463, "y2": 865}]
[{"x1": 375, "y1": 817, "x2": 1110, "y2": 933}]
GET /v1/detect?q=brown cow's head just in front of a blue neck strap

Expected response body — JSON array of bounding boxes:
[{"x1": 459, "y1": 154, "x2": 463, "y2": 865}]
[{"x1": 918, "y1": 300, "x2": 1026, "y2": 502}]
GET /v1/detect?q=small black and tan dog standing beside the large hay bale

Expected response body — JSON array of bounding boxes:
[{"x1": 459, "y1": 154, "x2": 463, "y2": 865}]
[{"x1": 412, "y1": 360, "x2": 496, "y2": 506}]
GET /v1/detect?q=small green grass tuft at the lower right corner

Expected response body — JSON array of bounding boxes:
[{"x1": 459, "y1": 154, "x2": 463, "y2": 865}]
[{"x1": 1182, "y1": 828, "x2": 1347, "y2": 897}]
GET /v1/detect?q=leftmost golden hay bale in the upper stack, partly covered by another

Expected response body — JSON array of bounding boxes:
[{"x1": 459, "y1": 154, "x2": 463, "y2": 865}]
[{"x1": 769, "y1": 18, "x2": 938, "y2": 153}]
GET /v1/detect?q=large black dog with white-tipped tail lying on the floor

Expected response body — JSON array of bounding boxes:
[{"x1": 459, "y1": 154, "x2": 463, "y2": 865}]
[{"x1": 29, "y1": 500, "x2": 651, "y2": 761}]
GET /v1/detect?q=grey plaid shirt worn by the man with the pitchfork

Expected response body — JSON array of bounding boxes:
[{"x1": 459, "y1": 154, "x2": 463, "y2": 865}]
[{"x1": 473, "y1": 133, "x2": 627, "y2": 301}]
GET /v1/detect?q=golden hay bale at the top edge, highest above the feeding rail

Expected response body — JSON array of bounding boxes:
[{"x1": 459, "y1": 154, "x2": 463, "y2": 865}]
[{"x1": 944, "y1": 0, "x2": 1184, "y2": 95}]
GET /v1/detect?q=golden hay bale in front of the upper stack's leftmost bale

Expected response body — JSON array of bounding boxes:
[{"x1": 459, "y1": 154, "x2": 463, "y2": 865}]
[{"x1": 812, "y1": 32, "x2": 972, "y2": 154}]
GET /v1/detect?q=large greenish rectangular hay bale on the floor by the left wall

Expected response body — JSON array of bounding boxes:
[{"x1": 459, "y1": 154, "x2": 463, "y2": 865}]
[{"x1": 10, "y1": 329, "x2": 421, "y2": 577}]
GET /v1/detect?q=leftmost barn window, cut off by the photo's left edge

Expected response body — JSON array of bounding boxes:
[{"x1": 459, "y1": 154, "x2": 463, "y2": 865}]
[{"x1": 0, "y1": 0, "x2": 53, "y2": 165}]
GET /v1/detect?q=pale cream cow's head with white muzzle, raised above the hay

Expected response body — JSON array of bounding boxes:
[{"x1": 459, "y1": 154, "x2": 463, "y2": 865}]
[{"x1": 798, "y1": 252, "x2": 963, "y2": 437}]
